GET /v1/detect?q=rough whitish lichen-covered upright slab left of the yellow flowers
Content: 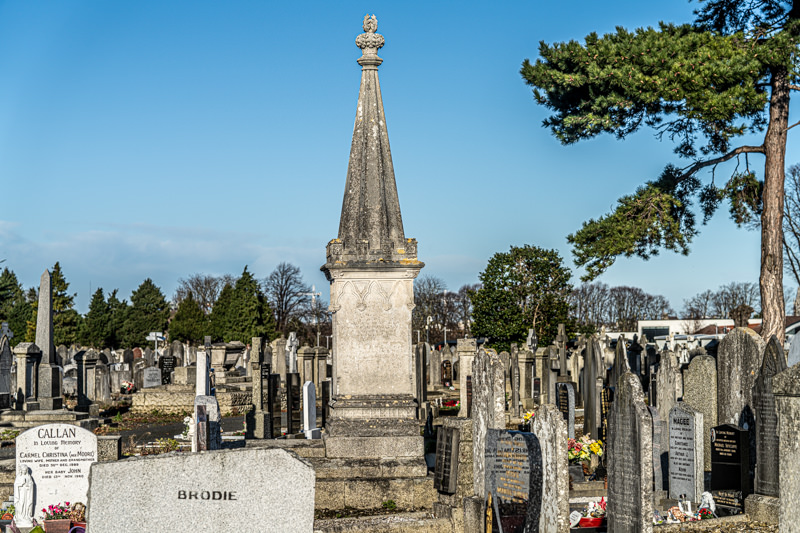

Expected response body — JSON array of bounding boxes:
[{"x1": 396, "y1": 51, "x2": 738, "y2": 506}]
[{"x1": 531, "y1": 405, "x2": 569, "y2": 533}]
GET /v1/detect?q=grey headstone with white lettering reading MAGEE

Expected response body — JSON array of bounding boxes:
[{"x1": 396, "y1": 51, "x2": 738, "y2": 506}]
[{"x1": 669, "y1": 402, "x2": 705, "y2": 503}]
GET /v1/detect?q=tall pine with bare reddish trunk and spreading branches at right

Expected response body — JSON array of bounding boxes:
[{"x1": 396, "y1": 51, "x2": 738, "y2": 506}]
[{"x1": 521, "y1": 0, "x2": 800, "y2": 339}]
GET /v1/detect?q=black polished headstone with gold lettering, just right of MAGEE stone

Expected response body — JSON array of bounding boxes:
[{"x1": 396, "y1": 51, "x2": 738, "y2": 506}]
[{"x1": 711, "y1": 424, "x2": 752, "y2": 515}]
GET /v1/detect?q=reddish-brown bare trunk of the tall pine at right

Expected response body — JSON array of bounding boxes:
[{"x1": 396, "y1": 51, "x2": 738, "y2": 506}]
[{"x1": 759, "y1": 69, "x2": 790, "y2": 344}]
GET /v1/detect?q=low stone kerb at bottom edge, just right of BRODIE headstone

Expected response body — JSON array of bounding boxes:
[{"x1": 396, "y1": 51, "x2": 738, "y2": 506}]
[{"x1": 314, "y1": 513, "x2": 453, "y2": 533}]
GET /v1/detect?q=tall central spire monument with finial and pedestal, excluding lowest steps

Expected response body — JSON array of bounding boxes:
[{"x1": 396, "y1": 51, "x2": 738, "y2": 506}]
[{"x1": 321, "y1": 15, "x2": 424, "y2": 459}]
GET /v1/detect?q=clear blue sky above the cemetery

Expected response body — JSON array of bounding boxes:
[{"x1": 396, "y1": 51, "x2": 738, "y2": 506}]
[{"x1": 0, "y1": 0, "x2": 798, "y2": 312}]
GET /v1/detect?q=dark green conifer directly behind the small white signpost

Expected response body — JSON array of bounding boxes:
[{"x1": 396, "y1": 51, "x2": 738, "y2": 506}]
[{"x1": 122, "y1": 278, "x2": 169, "y2": 348}]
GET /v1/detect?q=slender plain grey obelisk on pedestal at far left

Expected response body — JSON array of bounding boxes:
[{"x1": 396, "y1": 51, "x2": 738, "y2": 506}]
[{"x1": 36, "y1": 270, "x2": 63, "y2": 410}]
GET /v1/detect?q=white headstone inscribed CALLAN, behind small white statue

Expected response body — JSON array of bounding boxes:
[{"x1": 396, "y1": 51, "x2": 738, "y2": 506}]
[{"x1": 16, "y1": 424, "x2": 97, "y2": 520}]
